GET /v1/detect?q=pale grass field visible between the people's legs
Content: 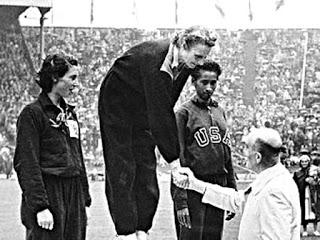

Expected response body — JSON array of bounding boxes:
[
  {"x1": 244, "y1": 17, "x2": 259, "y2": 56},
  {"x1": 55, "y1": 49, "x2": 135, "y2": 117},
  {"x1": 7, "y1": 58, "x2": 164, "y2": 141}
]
[{"x1": 0, "y1": 169, "x2": 320, "y2": 240}]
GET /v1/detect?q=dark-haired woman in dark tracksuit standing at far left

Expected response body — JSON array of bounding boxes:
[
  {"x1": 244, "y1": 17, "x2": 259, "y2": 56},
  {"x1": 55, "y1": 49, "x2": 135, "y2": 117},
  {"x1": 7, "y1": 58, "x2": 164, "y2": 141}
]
[{"x1": 14, "y1": 55, "x2": 91, "y2": 240}]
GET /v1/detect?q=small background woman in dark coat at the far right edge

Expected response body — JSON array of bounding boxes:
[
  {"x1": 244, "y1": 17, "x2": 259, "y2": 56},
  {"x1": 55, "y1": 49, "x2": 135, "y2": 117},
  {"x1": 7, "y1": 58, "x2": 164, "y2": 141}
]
[{"x1": 293, "y1": 154, "x2": 320, "y2": 236}]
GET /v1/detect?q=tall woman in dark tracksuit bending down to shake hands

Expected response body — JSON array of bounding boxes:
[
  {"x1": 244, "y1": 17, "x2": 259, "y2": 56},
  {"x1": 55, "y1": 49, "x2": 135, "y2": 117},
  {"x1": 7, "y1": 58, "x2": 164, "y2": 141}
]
[{"x1": 99, "y1": 27, "x2": 216, "y2": 239}]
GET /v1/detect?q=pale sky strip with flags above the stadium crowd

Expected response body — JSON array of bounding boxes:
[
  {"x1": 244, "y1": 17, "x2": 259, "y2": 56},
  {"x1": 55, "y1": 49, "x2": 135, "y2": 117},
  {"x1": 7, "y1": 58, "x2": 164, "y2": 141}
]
[{"x1": 20, "y1": 0, "x2": 320, "y2": 29}]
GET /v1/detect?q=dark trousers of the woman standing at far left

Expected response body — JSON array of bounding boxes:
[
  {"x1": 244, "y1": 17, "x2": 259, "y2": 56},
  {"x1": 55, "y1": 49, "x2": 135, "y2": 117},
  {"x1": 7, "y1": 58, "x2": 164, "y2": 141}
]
[{"x1": 21, "y1": 176, "x2": 87, "y2": 240}]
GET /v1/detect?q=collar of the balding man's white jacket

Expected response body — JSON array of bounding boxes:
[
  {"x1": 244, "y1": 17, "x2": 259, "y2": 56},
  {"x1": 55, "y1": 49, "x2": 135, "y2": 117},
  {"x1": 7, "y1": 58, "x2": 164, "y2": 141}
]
[{"x1": 251, "y1": 162, "x2": 289, "y2": 195}]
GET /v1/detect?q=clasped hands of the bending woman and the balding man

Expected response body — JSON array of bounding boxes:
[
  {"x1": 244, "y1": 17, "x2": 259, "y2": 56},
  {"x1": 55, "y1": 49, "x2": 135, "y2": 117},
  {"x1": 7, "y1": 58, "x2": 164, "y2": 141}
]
[{"x1": 171, "y1": 167, "x2": 206, "y2": 193}]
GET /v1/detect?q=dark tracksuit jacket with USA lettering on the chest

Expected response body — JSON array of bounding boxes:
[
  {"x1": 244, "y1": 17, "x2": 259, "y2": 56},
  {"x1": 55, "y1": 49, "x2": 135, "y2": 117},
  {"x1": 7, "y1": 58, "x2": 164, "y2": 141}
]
[{"x1": 172, "y1": 96, "x2": 236, "y2": 209}]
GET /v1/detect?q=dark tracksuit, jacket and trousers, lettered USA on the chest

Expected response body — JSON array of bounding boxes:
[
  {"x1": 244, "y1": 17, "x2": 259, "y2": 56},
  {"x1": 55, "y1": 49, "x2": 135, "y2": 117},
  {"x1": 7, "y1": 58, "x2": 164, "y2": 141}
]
[{"x1": 171, "y1": 96, "x2": 236, "y2": 240}]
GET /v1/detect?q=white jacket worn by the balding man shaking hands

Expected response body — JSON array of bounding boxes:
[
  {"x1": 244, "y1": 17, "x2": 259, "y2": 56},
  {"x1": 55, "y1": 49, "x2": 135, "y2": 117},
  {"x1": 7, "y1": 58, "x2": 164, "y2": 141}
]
[{"x1": 202, "y1": 163, "x2": 301, "y2": 240}]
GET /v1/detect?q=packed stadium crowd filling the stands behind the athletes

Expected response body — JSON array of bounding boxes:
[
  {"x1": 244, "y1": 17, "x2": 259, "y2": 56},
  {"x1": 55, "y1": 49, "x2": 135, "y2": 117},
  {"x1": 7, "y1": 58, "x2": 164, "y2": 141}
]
[{"x1": 0, "y1": 26, "x2": 320, "y2": 176}]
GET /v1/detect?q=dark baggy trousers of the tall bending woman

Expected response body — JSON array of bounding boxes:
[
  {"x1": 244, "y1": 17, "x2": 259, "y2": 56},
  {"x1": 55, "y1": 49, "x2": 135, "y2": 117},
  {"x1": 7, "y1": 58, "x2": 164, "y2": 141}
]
[{"x1": 101, "y1": 123, "x2": 159, "y2": 235}]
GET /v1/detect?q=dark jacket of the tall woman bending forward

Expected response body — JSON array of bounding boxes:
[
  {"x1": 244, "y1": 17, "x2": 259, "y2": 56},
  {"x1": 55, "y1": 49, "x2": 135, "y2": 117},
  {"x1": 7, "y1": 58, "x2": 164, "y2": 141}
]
[{"x1": 99, "y1": 40, "x2": 190, "y2": 162}]
